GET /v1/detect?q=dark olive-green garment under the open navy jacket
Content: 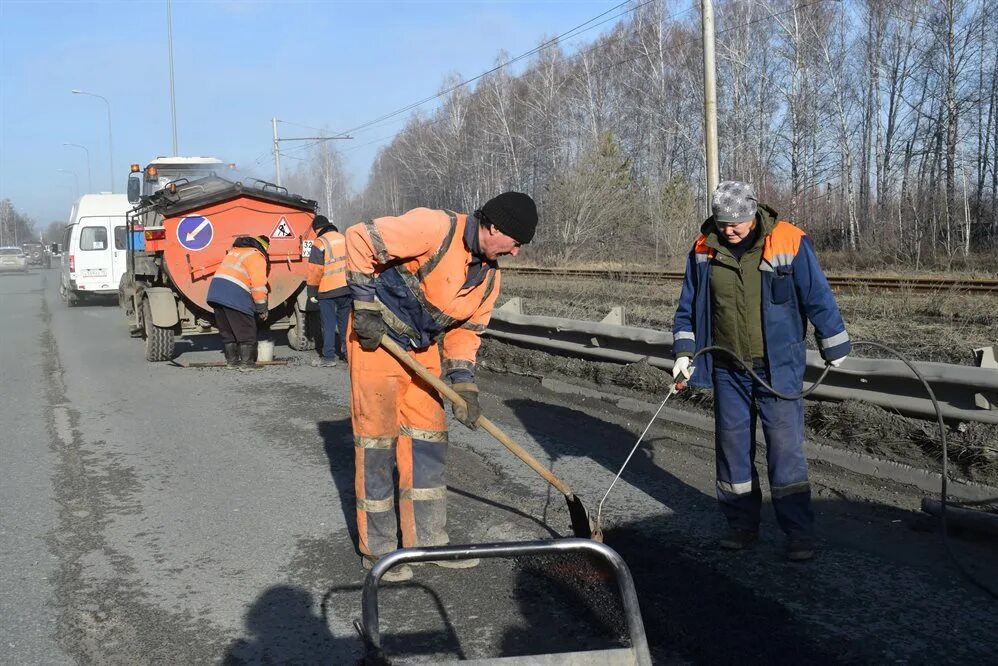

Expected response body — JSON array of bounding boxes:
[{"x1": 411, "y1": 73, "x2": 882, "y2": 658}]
[{"x1": 700, "y1": 205, "x2": 777, "y2": 363}]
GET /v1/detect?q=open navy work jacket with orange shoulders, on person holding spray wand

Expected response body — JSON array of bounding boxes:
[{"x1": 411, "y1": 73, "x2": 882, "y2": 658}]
[{"x1": 672, "y1": 205, "x2": 851, "y2": 393}]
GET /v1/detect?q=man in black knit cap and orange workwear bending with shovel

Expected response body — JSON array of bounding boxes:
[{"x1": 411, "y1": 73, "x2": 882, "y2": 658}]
[{"x1": 346, "y1": 192, "x2": 537, "y2": 581}]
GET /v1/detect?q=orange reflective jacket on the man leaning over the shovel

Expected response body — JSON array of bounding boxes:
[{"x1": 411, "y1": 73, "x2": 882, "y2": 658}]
[{"x1": 346, "y1": 208, "x2": 500, "y2": 372}]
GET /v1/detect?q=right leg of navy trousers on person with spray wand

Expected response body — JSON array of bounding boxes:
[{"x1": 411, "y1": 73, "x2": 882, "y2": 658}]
[{"x1": 755, "y1": 375, "x2": 814, "y2": 536}]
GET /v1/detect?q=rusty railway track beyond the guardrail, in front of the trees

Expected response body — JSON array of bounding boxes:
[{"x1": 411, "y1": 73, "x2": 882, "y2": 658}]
[{"x1": 503, "y1": 266, "x2": 998, "y2": 294}]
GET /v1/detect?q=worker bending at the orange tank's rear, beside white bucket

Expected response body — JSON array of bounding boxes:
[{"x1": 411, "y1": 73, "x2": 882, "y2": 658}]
[{"x1": 208, "y1": 236, "x2": 270, "y2": 370}]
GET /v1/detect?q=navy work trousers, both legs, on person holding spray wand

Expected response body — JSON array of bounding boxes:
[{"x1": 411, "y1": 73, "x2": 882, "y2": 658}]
[{"x1": 713, "y1": 366, "x2": 814, "y2": 537}]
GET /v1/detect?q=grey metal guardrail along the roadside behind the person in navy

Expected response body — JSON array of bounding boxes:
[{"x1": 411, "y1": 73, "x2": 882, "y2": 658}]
[{"x1": 485, "y1": 306, "x2": 998, "y2": 423}]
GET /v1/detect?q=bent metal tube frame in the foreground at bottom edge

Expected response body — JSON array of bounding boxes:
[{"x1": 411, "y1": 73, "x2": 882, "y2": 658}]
[{"x1": 357, "y1": 539, "x2": 651, "y2": 666}]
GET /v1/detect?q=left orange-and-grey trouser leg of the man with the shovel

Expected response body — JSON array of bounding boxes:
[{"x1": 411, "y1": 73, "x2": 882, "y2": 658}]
[{"x1": 350, "y1": 339, "x2": 405, "y2": 557}]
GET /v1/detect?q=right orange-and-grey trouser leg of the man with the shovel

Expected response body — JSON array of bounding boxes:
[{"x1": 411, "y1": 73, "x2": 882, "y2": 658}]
[{"x1": 399, "y1": 345, "x2": 449, "y2": 547}]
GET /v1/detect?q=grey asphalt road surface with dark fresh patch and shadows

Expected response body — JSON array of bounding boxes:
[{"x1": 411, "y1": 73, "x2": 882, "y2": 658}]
[{"x1": 0, "y1": 270, "x2": 998, "y2": 664}]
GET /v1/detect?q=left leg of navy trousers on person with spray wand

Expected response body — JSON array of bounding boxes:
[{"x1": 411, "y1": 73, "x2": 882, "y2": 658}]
[{"x1": 713, "y1": 366, "x2": 762, "y2": 531}]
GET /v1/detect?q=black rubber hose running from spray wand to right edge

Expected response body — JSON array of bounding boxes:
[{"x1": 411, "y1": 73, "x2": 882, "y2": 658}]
[{"x1": 690, "y1": 340, "x2": 998, "y2": 599}]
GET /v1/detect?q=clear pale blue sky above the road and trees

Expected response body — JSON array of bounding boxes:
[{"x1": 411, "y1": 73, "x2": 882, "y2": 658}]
[{"x1": 0, "y1": 0, "x2": 619, "y2": 228}]
